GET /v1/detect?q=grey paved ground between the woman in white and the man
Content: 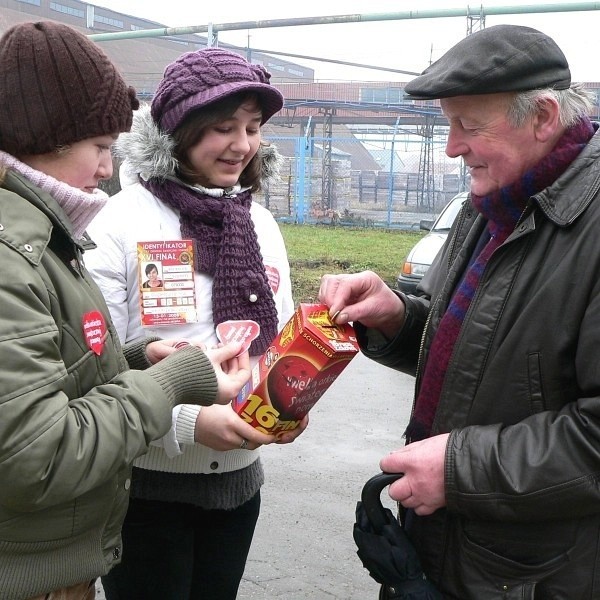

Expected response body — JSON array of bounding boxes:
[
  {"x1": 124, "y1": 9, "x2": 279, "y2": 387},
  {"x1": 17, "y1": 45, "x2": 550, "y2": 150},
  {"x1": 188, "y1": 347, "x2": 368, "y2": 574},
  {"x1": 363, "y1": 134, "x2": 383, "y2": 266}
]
[{"x1": 97, "y1": 355, "x2": 413, "y2": 600}]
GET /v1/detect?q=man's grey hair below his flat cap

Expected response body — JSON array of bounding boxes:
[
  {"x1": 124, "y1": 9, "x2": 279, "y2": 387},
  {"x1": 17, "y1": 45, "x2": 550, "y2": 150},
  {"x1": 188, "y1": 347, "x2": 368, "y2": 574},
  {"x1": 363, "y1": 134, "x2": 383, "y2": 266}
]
[{"x1": 507, "y1": 83, "x2": 596, "y2": 127}]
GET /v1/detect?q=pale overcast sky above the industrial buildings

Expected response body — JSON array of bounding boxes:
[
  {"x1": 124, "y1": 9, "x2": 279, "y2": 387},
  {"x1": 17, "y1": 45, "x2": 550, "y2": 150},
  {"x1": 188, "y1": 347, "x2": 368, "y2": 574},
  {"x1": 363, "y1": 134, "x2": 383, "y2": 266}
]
[{"x1": 94, "y1": 0, "x2": 600, "y2": 82}]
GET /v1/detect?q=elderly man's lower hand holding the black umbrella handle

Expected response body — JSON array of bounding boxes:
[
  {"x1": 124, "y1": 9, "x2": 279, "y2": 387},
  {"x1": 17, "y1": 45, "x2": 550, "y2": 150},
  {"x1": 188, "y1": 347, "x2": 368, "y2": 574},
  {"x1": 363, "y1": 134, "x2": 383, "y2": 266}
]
[{"x1": 379, "y1": 433, "x2": 450, "y2": 515}]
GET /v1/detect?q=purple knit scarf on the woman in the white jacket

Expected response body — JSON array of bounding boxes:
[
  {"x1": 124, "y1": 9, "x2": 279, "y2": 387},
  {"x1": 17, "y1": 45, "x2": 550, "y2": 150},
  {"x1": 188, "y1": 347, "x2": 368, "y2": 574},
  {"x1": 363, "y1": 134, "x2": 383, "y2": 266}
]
[{"x1": 142, "y1": 179, "x2": 277, "y2": 356}]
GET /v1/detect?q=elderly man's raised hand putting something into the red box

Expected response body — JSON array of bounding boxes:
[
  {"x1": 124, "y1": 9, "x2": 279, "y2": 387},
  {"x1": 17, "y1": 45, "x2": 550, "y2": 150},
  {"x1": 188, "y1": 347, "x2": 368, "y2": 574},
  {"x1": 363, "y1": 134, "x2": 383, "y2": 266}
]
[{"x1": 319, "y1": 271, "x2": 405, "y2": 338}]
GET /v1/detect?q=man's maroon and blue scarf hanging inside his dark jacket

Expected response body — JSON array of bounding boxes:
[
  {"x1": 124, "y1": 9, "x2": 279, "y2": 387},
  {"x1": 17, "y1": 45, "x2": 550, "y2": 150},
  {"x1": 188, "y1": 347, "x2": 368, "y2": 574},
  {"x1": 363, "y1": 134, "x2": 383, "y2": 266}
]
[{"x1": 406, "y1": 118, "x2": 595, "y2": 442}]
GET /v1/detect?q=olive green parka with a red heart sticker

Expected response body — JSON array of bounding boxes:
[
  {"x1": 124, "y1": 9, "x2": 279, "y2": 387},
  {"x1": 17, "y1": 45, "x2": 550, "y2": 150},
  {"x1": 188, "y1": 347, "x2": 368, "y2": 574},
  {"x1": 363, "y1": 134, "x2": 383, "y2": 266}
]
[{"x1": 0, "y1": 171, "x2": 217, "y2": 600}]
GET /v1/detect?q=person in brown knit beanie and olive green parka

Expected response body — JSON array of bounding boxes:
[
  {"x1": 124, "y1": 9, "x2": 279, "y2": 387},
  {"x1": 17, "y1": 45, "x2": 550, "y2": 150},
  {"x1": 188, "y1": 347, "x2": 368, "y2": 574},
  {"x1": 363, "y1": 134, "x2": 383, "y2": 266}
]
[{"x1": 0, "y1": 22, "x2": 250, "y2": 600}]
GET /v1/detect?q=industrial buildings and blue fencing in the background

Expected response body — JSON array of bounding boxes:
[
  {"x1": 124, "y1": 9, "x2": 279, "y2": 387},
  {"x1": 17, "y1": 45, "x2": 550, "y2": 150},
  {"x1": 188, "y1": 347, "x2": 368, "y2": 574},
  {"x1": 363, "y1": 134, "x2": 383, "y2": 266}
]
[{"x1": 0, "y1": 0, "x2": 600, "y2": 227}]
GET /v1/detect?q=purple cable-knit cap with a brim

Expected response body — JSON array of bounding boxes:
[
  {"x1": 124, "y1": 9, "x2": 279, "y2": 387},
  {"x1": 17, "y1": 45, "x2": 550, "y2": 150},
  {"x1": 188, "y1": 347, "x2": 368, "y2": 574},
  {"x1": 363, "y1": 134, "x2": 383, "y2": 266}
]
[{"x1": 151, "y1": 48, "x2": 283, "y2": 133}]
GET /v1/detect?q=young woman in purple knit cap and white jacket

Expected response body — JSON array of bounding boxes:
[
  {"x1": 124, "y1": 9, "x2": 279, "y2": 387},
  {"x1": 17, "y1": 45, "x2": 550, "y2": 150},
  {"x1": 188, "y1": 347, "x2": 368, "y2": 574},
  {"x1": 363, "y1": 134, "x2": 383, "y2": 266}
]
[{"x1": 88, "y1": 48, "x2": 306, "y2": 600}]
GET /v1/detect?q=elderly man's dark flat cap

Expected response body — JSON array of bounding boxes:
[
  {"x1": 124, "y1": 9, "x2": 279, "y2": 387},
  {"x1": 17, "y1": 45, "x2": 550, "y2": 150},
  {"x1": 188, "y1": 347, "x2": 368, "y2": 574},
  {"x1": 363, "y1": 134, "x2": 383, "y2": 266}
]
[{"x1": 404, "y1": 25, "x2": 571, "y2": 100}]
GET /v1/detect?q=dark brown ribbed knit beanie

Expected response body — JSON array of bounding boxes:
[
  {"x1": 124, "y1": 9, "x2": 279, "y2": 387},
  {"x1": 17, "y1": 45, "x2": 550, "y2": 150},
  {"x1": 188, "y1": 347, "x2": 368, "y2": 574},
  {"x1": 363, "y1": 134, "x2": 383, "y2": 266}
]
[{"x1": 0, "y1": 21, "x2": 139, "y2": 157}]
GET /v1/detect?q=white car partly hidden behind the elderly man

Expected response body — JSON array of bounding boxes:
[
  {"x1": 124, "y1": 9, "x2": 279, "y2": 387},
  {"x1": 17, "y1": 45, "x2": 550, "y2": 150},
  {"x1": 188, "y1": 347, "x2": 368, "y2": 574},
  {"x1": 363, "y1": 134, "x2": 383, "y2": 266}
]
[{"x1": 397, "y1": 192, "x2": 468, "y2": 294}]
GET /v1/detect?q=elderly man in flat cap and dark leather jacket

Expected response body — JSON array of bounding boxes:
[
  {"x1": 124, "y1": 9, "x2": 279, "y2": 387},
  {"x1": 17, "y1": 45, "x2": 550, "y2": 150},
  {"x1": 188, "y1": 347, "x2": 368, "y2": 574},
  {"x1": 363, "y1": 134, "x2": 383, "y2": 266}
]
[{"x1": 320, "y1": 25, "x2": 600, "y2": 600}]
